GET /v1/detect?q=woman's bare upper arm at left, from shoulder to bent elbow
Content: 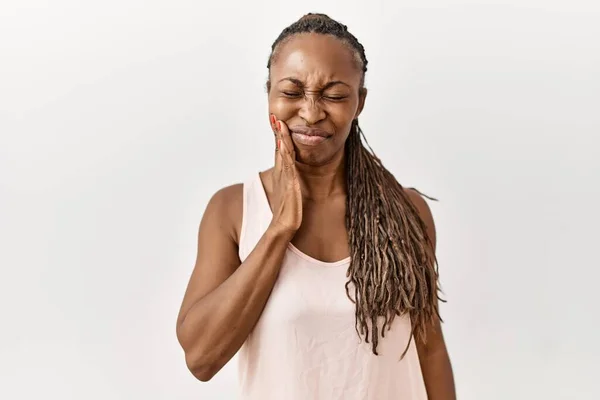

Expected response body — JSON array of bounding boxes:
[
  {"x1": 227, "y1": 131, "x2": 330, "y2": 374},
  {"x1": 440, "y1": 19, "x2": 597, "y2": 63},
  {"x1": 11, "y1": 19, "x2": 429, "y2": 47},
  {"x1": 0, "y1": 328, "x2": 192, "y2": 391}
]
[{"x1": 177, "y1": 184, "x2": 243, "y2": 329}]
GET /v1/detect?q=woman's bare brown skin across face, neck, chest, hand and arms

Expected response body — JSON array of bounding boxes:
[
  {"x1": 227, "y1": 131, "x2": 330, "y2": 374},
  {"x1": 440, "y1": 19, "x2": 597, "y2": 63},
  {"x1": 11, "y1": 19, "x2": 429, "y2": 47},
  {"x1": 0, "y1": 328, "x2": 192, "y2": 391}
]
[{"x1": 177, "y1": 34, "x2": 456, "y2": 400}]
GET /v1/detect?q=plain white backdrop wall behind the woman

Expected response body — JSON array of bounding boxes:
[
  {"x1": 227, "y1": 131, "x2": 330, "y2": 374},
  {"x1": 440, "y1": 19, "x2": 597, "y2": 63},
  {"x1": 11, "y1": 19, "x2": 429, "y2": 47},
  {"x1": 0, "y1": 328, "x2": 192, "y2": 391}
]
[{"x1": 0, "y1": 0, "x2": 600, "y2": 400}]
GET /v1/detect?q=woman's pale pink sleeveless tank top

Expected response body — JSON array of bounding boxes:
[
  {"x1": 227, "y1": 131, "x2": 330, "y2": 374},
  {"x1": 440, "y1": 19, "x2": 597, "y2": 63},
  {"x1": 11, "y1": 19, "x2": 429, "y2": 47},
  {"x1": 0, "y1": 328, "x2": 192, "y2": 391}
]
[{"x1": 238, "y1": 174, "x2": 427, "y2": 400}]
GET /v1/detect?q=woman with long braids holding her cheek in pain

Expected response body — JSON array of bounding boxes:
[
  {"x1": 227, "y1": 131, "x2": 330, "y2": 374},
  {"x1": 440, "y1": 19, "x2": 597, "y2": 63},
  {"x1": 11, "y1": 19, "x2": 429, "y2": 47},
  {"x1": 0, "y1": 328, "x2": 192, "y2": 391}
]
[{"x1": 177, "y1": 14, "x2": 455, "y2": 400}]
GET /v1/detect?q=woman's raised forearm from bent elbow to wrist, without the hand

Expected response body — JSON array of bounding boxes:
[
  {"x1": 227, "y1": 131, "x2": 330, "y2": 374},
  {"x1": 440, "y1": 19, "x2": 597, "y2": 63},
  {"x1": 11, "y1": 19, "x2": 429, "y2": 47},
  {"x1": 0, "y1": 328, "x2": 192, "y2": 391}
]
[{"x1": 179, "y1": 223, "x2": 291, "y2": 380}]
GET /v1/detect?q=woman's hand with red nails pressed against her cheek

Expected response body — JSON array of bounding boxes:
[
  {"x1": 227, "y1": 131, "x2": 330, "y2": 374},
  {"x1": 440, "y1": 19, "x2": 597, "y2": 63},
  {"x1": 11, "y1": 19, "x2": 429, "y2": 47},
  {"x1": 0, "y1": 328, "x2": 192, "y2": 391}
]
[{"x1": 271, "y1": 114, "x2": 302, "y2": 236}]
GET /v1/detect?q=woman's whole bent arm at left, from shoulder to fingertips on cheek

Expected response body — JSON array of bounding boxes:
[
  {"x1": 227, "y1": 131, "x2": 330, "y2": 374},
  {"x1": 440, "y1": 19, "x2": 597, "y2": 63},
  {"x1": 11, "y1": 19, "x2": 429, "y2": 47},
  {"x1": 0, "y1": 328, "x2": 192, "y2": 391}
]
[{"x1": 177, "y1": 118, "x2": 302, "y2": 381}]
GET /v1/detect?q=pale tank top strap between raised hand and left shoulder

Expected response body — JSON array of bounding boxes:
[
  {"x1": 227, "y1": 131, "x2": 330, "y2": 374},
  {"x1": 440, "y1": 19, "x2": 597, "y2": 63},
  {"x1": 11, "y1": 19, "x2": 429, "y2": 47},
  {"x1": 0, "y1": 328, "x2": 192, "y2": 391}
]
[{"x1": 239, "y1": 172, "x2": 272, "y2": 262}]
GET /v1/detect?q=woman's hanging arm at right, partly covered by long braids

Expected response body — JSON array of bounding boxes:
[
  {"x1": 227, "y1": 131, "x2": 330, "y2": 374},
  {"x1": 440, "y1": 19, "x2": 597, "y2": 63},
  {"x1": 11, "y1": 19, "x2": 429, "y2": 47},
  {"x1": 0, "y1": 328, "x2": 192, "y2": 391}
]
[{"x1": 406, "y1": 189, "x2": 456, "y2": 400}]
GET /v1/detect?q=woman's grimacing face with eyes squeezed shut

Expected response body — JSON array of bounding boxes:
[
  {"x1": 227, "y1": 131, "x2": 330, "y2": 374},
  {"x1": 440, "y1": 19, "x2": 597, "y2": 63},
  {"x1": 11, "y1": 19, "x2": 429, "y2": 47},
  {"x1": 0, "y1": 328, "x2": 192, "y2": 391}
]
[{"x1": 269, "y1": 33, "x2": 366, "y2": 166}]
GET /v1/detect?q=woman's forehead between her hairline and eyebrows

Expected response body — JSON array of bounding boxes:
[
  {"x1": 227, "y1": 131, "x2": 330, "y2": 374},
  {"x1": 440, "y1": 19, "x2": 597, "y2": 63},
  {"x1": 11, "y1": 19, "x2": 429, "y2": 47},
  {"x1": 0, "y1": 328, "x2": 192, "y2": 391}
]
[{"x1": 271, "y1": 33, "x2": 362, "y2": 86}]
